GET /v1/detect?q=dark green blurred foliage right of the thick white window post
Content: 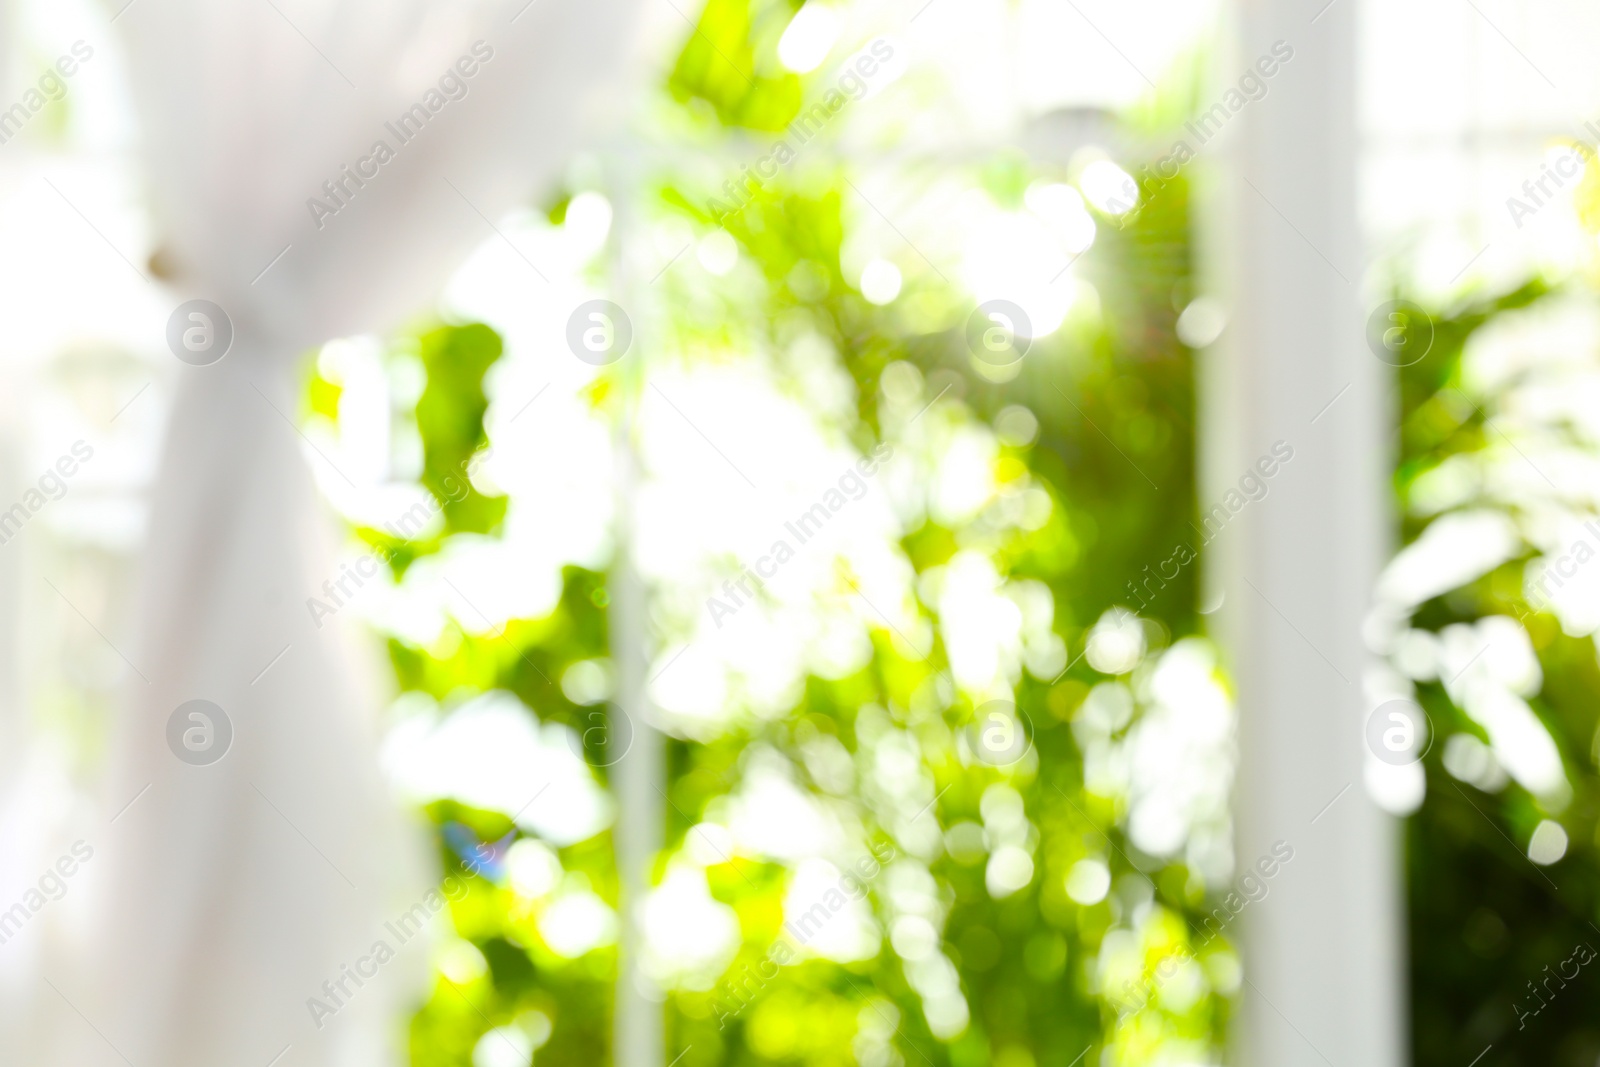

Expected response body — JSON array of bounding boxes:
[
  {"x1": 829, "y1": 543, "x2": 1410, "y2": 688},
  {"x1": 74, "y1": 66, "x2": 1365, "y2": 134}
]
[{"x1": 1397, "y1": 278, "x2": 1600, "y2": 1067}]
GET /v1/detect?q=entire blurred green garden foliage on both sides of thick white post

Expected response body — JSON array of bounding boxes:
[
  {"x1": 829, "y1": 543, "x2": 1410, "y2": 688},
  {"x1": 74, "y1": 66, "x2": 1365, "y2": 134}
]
[{"x1": 300, "y1": 0, "x2": 1600, "y2": 1067}]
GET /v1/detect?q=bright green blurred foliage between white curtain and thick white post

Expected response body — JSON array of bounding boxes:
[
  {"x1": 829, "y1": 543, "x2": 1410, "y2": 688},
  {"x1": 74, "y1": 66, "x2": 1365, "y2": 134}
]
[{"x1": 312, "y1": 0, "x2": 1232, "y2": 1067}]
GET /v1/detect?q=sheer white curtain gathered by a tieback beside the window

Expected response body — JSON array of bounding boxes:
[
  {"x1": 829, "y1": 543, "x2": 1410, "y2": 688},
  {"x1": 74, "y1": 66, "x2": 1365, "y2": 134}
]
[{"x1": 39, "y1": 0, "x2": 634, "y2": 1067}]
